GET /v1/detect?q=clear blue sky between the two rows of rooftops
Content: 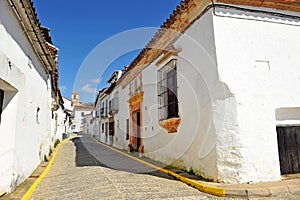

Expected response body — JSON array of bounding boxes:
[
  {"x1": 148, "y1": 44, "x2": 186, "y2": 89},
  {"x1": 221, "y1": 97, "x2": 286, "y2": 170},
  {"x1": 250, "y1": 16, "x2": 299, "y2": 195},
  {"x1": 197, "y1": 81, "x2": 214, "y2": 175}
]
[{"x1": 33, "y1": 0, "x2": 180, "y2": 102}]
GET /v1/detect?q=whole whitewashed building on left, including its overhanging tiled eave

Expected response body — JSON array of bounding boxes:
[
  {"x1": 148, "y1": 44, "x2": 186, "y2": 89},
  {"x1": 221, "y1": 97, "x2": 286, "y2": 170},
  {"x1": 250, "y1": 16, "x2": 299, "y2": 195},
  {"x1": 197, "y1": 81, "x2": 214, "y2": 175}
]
[{"x1": 0, "y1": 0, "x2": 62, "y2": 196}]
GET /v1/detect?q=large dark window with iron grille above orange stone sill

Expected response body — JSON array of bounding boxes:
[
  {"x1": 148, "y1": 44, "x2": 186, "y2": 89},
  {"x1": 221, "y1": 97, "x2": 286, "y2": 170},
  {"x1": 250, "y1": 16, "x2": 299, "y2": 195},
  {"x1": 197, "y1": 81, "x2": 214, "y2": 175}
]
[{"x1": 158, "y1": 59, "x2": 179, "y2": 120}]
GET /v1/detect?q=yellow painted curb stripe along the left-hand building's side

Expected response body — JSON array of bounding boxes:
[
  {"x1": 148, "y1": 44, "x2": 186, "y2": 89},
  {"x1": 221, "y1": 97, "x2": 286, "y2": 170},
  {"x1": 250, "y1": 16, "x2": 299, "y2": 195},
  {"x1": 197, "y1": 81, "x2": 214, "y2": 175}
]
[{"x1": 22, "y1": 137, "x2": 73, "y2": 200}]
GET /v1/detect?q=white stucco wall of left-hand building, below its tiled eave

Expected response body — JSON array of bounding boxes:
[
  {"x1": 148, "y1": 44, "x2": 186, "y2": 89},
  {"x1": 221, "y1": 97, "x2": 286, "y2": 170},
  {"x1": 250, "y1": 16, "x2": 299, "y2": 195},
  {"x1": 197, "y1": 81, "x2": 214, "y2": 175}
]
[{"x1": 0, "y1": 1, "x2": 51, "y2": 192}]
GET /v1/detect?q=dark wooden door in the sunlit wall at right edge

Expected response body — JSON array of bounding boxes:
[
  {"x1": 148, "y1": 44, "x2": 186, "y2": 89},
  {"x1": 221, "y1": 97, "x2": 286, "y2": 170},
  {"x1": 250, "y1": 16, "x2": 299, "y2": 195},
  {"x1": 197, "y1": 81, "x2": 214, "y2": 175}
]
[{"x1": 276, "y1": 126, "x2": 300, "y2": 174}]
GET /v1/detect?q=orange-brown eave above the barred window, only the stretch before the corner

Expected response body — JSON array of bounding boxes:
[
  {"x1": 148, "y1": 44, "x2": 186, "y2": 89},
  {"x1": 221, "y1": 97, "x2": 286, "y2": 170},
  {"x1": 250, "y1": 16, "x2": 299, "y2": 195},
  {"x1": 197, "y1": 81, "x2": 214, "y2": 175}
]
[{"x1": 120, "y1": 0, "x2": 211, "y2": 88}]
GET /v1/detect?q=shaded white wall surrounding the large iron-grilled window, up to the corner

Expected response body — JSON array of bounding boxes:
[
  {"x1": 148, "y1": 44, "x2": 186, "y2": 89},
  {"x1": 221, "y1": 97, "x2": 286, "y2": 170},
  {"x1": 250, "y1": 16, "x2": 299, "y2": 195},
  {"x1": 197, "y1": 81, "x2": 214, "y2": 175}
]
[{"x1": 138, "y1": 11, "x2": 218, "y2": 180}]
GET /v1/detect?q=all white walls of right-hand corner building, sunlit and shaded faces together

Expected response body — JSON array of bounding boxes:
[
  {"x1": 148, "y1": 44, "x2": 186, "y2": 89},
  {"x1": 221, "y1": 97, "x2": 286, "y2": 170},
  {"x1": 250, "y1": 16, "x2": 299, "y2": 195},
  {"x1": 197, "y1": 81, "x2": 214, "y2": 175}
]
[{"x1": 85, "y1": 4, "x2": 300, "y2": 183}]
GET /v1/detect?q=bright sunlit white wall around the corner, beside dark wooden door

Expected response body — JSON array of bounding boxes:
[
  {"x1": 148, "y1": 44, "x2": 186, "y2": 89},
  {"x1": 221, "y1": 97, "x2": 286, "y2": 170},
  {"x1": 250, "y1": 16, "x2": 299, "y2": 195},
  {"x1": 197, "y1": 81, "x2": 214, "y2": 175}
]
[{"x1": 214, "y1": 6, "x2": 300, "y2": 182}]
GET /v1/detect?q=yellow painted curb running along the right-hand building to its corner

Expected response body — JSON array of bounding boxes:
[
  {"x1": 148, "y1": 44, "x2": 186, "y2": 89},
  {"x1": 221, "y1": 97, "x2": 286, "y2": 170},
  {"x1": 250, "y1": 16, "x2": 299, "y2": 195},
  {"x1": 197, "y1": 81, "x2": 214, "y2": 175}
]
[{"x1": 92, "y1": 137, "x2": 226, "y2": 197}]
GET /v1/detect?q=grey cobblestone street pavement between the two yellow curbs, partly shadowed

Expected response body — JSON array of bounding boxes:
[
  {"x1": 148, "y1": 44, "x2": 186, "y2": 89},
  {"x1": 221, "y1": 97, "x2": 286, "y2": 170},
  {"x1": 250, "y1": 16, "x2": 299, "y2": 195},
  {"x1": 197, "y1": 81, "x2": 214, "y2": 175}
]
[{"x1": 31, "y1": 136, "x2": 221, "y2": 199}]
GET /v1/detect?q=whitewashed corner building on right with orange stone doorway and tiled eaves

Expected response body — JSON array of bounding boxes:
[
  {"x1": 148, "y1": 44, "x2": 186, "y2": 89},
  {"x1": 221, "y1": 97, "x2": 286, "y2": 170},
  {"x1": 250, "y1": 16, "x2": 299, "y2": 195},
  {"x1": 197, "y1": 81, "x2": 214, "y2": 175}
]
[{"x1": 90, "y1": 0, "x2": 300, "y2": 183}]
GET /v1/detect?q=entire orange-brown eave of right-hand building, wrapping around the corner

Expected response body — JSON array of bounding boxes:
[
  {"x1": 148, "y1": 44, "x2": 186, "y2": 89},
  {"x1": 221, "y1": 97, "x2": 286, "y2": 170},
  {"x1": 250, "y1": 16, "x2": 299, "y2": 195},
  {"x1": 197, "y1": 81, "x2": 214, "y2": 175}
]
[{"x1": 118, "y1": 0, "x2": 300, "y2": 88}]
